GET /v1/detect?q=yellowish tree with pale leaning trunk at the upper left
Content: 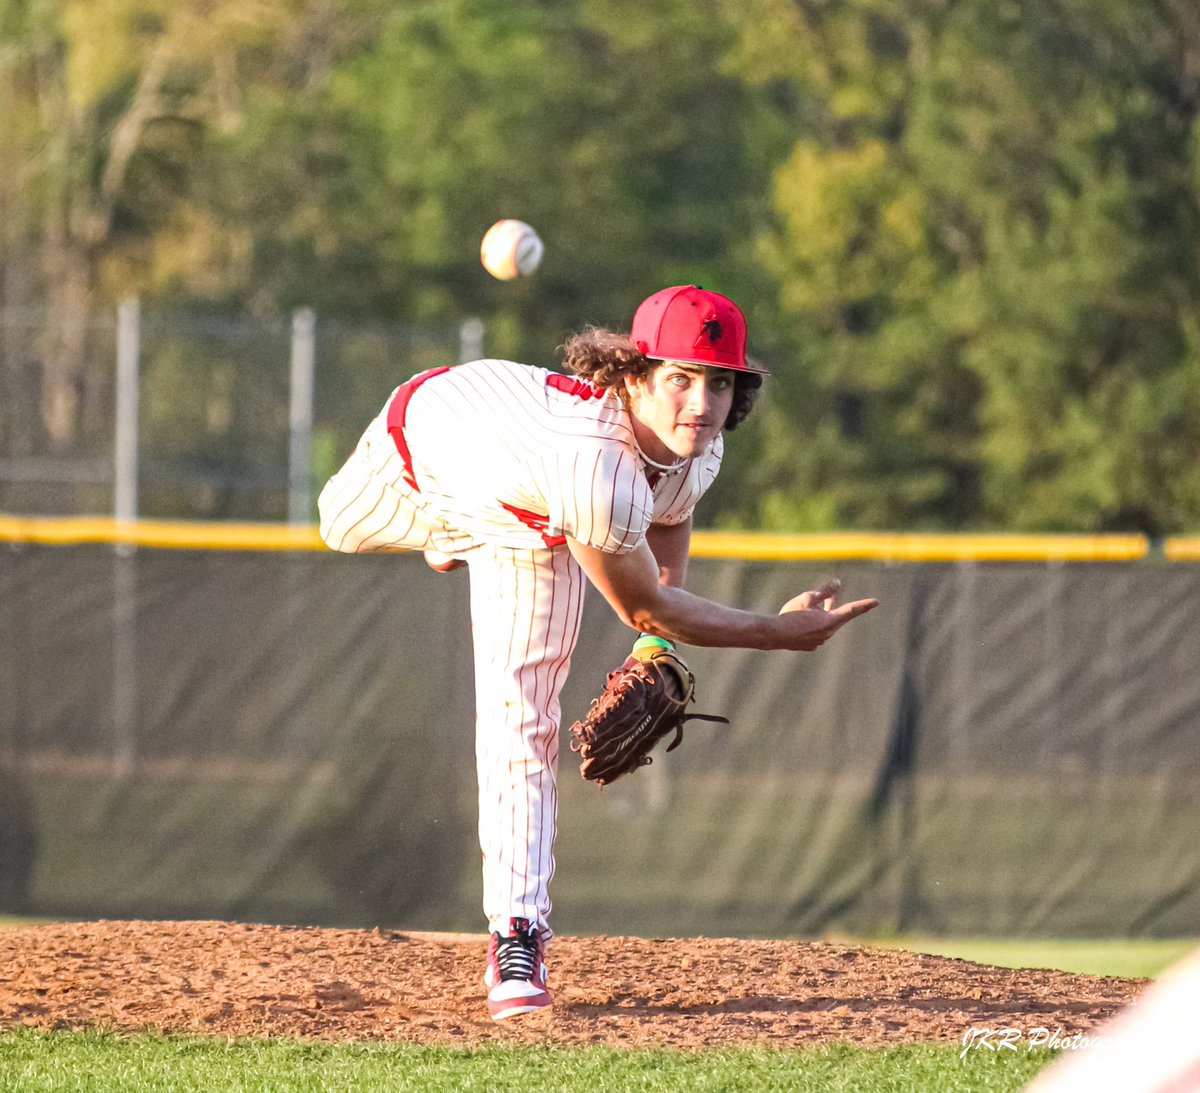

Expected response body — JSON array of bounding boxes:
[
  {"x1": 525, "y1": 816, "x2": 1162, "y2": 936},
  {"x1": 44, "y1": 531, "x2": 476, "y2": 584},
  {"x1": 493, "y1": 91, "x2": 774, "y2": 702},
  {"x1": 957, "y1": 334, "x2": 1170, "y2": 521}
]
[{"x1": 0, "y1": 0, "x2": 331, "y2": 451}]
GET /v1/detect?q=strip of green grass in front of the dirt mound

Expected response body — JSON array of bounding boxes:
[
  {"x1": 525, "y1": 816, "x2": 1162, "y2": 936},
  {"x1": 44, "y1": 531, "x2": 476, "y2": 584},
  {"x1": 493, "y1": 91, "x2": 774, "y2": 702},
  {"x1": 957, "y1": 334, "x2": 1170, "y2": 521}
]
[{"x1": 0, "y1": 1032, "x2": 1052, "y2": 1093}]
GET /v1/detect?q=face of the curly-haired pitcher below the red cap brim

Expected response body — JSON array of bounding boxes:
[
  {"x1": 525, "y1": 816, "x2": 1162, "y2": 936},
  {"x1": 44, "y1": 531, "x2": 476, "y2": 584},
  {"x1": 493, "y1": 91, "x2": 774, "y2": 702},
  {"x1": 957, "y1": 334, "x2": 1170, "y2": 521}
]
[{"x1": 629, "y1": 361, "x2": 734, "y2": 461}]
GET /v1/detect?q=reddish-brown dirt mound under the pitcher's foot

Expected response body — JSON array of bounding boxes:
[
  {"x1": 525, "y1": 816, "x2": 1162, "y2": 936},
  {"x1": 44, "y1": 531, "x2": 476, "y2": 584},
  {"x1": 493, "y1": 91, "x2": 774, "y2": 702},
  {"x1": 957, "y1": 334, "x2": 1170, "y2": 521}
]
[{"x1": 0, "y1": 921, "x2": 1146, "y2": 1050}]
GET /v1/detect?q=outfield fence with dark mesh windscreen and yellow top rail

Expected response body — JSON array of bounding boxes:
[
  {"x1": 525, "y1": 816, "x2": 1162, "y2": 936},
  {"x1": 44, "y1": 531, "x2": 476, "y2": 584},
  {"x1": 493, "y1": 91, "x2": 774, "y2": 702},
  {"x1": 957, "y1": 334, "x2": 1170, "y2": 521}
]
[{"x1": 0, "y1": 517, "x2": 1200, "y2": 937}]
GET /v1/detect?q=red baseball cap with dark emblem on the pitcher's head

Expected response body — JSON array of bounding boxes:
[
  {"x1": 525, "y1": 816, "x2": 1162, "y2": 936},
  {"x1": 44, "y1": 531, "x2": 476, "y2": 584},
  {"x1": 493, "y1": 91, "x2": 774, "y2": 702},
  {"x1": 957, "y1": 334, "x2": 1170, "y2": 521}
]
[{"x1": 629, "y1": 284, "x2": 769, "y2": 376}]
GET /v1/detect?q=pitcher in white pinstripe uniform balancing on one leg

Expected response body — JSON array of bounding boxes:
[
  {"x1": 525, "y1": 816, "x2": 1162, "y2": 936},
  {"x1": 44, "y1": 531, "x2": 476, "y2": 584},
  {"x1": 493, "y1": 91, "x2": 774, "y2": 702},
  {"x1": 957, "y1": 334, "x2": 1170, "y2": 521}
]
[{"x1": 318, "y1": 286, "x2": 877, "y2": 1020}]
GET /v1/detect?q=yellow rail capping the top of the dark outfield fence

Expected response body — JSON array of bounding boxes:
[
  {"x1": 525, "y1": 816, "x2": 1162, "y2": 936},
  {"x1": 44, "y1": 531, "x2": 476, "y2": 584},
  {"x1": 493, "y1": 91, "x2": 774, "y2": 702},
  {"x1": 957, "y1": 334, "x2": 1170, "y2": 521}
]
[{"x1": 0, "y1": 515, "x2": 1180, "y2": 563}]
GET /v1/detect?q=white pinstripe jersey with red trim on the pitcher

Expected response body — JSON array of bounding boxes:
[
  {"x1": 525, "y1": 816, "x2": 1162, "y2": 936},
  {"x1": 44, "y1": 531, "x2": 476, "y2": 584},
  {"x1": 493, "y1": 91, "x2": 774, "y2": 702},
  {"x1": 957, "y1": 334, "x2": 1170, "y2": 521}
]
[{"x1": 384, "y1": 360, "x2": 724, "y2": 554}]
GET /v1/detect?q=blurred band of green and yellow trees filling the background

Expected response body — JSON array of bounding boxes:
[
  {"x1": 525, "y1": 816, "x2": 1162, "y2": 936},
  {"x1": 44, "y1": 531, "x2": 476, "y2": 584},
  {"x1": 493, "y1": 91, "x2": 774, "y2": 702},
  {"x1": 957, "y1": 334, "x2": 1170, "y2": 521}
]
[{"x1": 0, "y1": 0, "x2": 1200, "y2": 534}]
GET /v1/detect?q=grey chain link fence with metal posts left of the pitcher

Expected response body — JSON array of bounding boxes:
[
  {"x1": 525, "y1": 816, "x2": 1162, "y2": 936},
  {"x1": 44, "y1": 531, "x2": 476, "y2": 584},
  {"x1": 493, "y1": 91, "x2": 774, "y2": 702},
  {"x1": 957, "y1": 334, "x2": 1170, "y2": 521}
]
[{"x1": 0, "y1": 307, "x2": 484, "y2": 521}]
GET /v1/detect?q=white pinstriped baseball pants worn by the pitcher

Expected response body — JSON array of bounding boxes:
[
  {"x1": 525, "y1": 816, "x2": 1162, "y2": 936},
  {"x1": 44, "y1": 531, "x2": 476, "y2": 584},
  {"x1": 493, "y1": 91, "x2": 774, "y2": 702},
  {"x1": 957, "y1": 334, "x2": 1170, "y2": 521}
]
[{"x1": 318, "y1": 452, "x2": 586, "y2": 939}]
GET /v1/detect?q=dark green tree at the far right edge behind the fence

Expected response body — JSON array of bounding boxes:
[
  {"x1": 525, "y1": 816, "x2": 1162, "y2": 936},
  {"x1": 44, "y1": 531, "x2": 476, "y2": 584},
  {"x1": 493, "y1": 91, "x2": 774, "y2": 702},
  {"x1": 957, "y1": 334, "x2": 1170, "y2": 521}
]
[{"x1": 914, "y1": 0, "x2": 1200, "y2": 534}]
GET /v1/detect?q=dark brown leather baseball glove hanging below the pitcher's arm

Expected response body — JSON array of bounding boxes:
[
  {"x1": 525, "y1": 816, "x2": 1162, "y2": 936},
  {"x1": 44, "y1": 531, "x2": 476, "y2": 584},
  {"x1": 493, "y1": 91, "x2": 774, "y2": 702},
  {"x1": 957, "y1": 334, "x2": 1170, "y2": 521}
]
[{"x1": 571, "y1": 649, "x2": 730, "y2": 786}]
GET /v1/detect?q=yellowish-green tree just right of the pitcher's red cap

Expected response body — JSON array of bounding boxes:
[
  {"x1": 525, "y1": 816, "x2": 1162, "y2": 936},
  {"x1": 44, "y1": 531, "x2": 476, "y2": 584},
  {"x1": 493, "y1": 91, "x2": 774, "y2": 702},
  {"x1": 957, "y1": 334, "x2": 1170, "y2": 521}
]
[{"x1": 715, "y1": 0, "x2": 978, "y2": 530}]
